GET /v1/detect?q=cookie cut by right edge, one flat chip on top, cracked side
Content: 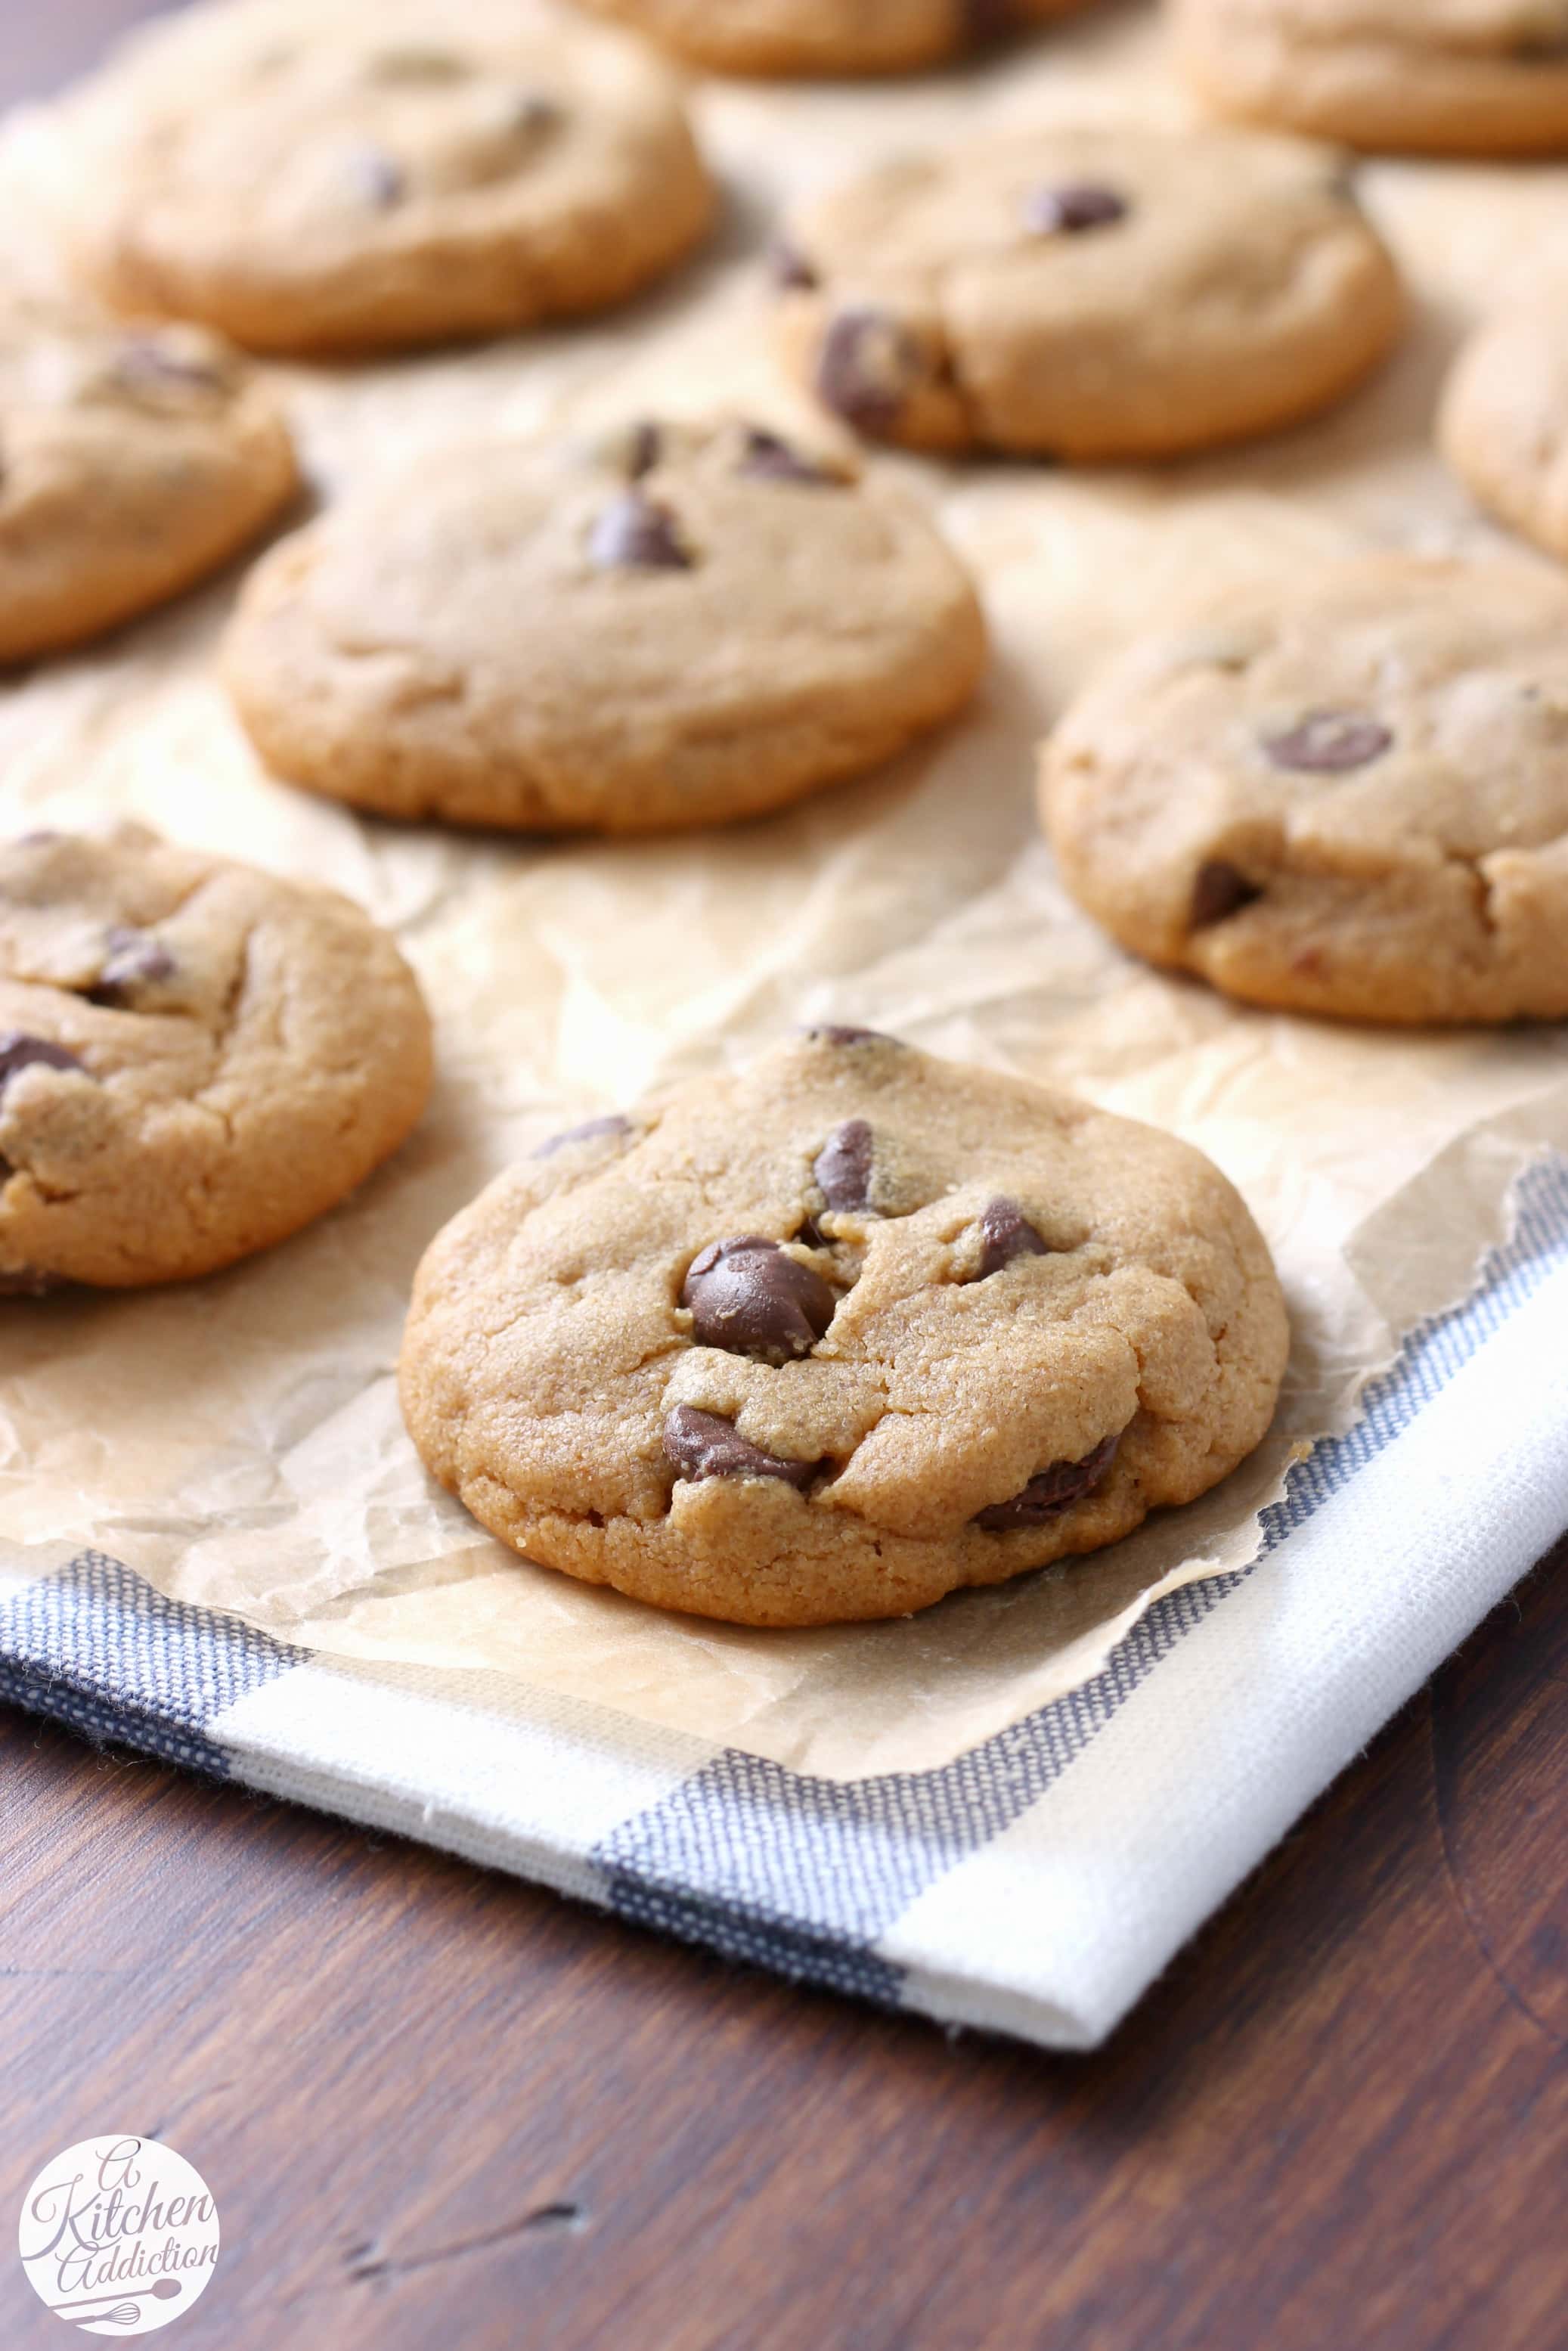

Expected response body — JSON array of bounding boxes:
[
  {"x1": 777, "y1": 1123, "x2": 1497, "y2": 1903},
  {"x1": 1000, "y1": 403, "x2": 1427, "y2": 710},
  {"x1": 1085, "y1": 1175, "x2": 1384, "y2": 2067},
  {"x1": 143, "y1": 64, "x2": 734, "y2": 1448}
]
[{"x1": 1041, "y1": 555, "x2": 1568, "y2": 1020}]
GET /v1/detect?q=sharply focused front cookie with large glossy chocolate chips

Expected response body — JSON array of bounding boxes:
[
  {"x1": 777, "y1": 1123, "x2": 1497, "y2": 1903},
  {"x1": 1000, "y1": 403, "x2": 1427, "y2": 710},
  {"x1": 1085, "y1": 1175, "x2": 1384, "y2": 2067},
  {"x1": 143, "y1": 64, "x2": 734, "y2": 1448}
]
[{"x1": 402, "y1": 1028, "x2": 1286, "y2": 1624}]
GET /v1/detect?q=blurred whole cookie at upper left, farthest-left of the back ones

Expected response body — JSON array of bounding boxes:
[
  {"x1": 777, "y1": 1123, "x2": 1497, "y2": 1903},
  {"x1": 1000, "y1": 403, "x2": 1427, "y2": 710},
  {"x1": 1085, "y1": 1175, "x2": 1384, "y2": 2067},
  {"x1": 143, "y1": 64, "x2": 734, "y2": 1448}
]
[{"x1": 76, "y1": 0, "x2": 714, "y2": 352}]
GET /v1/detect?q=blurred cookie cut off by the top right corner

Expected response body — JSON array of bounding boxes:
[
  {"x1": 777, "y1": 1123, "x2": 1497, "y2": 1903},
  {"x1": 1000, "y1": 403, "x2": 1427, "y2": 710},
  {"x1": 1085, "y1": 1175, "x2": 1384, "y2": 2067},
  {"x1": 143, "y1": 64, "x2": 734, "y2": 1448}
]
[{"x1": 1173, "y1": 0, "x2": 1568, "y2": 155}]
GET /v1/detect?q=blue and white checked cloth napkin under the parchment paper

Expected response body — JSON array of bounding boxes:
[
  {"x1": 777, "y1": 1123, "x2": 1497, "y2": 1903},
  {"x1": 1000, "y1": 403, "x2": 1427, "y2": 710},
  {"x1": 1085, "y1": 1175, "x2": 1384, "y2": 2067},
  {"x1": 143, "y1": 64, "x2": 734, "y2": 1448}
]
[{"x1": 0, "y1": 1162, "x2": 1568, "y2": 2048}]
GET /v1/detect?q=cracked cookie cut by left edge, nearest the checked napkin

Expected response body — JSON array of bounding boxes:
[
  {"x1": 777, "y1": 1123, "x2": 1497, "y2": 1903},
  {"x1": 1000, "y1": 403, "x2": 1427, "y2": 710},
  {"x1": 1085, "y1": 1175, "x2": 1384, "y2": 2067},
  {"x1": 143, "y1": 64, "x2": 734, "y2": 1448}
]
[{"x1": 0, "y1": 825, "x2": 430, "y2": 1295}]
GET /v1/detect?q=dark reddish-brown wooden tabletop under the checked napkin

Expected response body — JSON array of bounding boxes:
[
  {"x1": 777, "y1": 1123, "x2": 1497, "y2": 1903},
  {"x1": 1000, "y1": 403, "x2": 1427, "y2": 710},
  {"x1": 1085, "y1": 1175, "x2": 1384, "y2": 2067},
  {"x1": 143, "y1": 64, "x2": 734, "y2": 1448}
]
[{"x1": 0, "y1": 0, "x2": 1568, "y2": 2351}]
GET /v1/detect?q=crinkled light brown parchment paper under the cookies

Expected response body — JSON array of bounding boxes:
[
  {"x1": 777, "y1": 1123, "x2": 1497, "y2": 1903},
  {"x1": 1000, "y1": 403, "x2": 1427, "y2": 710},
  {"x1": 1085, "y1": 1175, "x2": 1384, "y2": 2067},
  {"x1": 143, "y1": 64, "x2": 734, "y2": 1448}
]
[{"x1": 0, "y1": 7, "x2": 1568, "y2": 1777}]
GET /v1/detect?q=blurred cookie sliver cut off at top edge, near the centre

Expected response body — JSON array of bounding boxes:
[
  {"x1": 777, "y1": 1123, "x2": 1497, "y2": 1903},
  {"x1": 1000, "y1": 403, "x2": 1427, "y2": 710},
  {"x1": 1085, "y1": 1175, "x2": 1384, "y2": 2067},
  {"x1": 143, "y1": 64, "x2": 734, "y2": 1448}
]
[{"x1": 571, "y1": 0, "x2": 1086, "y2": 75}]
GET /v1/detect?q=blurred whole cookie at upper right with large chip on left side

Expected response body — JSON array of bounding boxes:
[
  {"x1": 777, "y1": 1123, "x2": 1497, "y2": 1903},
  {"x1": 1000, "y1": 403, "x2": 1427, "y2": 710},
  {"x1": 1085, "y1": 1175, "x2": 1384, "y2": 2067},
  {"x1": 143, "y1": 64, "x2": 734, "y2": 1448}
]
[{"x1": 776, "y1": 129, "x2": 1401, "y2": 458}]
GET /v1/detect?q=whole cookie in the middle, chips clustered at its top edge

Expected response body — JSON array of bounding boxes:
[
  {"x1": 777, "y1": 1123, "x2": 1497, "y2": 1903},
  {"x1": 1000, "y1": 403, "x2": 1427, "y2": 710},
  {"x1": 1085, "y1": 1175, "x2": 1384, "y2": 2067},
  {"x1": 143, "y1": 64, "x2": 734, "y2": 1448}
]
[{"x1": 226, "y1": 423, "x2": 985, "y2": 833}]
